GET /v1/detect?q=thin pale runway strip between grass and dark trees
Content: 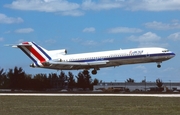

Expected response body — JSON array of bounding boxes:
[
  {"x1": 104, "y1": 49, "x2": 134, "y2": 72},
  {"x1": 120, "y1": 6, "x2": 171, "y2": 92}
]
[{"x1": 0, "y1": 93, "x2": 180, "y2": 97}]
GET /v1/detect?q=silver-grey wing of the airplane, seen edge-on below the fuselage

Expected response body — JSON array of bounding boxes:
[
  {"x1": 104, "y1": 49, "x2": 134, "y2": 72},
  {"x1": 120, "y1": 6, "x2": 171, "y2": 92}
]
[{"x1": 43, "y1": 60, "x2": 109, "y2": 69}]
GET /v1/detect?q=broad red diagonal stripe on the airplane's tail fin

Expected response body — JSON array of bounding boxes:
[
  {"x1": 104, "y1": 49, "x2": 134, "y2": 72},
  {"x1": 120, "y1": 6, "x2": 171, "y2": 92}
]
[{"x1": 25, "y1": 46, "x2": 46, "y2": 62}]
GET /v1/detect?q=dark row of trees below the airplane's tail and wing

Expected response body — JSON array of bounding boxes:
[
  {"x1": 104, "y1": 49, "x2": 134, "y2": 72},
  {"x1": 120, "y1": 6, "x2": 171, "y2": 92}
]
[{"x1": 0, "y1": 67, "x2": 99, "y2": 91}]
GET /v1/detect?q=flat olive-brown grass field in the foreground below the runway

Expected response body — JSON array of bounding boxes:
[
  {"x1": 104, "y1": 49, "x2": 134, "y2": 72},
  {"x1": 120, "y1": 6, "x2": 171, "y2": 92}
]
[{"x1": 0, "y1": 96, "x2": 180, "y2": 115}]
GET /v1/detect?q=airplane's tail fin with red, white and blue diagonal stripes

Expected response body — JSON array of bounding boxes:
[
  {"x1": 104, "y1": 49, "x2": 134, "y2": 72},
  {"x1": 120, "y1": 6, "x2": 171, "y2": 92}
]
[{"x1": 13, "y1": 42, "x2": 52, "y2": 66}]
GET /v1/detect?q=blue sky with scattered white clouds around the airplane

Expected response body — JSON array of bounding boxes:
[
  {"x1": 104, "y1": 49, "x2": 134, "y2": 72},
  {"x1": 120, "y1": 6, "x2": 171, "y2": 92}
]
[{"x1": 0, "y1": 0, "x2": 180, "y2": 82}]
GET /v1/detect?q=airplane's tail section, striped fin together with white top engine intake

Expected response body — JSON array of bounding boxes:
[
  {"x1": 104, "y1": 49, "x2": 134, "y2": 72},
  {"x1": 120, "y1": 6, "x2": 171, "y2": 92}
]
[{"x1": 12, "y1": 42, "x2": 67, "y2": 67}]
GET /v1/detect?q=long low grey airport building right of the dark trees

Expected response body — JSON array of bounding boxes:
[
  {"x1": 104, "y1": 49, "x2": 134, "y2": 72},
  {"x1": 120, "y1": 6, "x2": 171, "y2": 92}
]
[{"x1": 93, "y1": 82, "x2": 180, "y2": 92}]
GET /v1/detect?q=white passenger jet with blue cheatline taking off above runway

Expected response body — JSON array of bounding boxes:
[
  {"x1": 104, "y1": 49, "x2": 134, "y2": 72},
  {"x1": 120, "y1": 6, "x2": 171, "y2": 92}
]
[{"x1": 12, "y1": 42, "x2": 175, "y2": 75}]
